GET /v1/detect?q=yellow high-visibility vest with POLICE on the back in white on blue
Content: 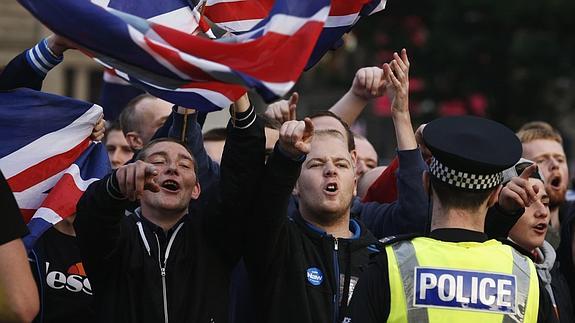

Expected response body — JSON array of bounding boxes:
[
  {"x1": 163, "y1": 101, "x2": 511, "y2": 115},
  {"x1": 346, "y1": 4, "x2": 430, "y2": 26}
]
[{"x1": 386, "y1": 238, "x2": 539, "y2": 323}]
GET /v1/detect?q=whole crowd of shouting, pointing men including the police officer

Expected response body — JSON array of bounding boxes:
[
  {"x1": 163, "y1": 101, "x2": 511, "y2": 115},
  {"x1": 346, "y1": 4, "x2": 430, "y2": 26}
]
[{"x1": 0, "y1": 35, "x2": 575, "y2": 323}]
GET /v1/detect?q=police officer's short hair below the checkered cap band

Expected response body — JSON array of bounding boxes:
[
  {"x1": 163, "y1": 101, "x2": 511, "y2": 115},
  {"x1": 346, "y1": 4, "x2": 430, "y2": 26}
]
[{"x1": 429, "y1": 174, "x2": 499, "y2": 211}]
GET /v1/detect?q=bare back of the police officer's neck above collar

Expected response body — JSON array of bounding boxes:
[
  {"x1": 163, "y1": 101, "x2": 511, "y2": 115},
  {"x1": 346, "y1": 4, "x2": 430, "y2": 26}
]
[{"x1": 431, "y1": 203, "x2": 487, "y2": 232}]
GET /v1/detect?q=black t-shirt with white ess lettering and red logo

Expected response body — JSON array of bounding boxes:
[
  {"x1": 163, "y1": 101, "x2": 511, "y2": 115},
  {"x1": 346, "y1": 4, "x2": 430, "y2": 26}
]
[{"x1": 32, "y1": 228, "x2": 95, "y2": 323}]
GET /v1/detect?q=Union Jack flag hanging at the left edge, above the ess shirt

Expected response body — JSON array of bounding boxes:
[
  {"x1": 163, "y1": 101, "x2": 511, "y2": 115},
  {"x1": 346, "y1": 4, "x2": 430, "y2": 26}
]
[{"x1": 0, "y1": 89, "x2": 110, "y2": 248}]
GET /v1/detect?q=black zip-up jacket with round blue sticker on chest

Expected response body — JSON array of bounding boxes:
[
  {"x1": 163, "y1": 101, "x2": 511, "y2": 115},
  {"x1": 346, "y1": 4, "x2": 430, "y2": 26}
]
[{"x1": 244, "y1": 148, "x2": 380, "y2": 323}]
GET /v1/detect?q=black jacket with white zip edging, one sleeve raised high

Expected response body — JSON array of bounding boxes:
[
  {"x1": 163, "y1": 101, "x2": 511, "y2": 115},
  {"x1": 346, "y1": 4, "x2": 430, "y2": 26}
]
[{"x1": 74, "y1": 109, "x2": 265, "y2": 323}]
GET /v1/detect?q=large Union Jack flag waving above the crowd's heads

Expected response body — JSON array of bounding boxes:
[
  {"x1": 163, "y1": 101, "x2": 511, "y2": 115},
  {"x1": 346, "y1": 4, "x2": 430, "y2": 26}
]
[{"x1": 19, "y1": 0, "x2": 330, "y2": 111}]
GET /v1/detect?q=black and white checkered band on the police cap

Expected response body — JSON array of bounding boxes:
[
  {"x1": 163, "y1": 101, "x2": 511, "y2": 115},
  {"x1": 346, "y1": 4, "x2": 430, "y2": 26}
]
[{"x1": 429, "y1": 158, "x2": 503, "y2": 190}]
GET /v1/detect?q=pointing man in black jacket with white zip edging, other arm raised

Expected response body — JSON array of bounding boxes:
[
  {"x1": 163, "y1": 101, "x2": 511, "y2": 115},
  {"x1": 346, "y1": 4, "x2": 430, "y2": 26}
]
[{"x1": 74, "y1": 100, "x2": 265, "y2": 323}]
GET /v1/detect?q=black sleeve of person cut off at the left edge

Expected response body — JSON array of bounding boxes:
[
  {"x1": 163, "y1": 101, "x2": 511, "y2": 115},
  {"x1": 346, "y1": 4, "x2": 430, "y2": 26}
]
[{"x1": 0, "y1": 172, "x2": 28, "y2": 245}]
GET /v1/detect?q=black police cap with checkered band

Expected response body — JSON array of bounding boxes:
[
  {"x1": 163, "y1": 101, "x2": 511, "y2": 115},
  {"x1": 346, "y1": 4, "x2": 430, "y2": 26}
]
[{"x1": 423, "y1": 116, "x2": 522, "y2": 191}]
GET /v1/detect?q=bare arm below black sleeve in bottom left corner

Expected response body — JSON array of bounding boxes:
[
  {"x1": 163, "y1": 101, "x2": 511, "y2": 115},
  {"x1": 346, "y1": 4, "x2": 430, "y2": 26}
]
[{"x1": 0, "y1": 239, "x2": 40, "y2": 322}]
